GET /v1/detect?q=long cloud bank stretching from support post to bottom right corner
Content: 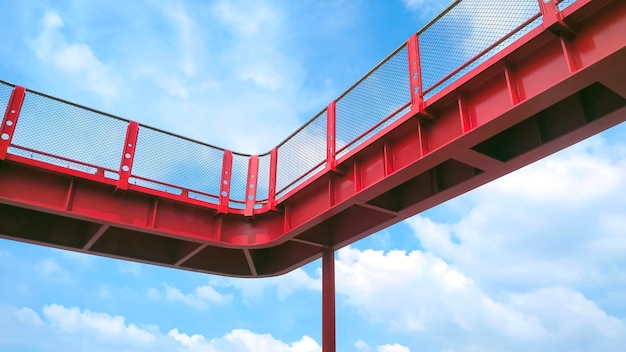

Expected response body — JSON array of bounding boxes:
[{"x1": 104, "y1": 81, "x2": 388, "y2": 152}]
[{"x1": 336, "y1": 247, "x2": 626, "y2": 351}]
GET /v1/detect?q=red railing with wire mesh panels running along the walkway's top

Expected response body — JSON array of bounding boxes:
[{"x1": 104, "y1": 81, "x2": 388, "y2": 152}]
[{"x1": 0, "y1": 0, "x2": 575, "y2": 216}]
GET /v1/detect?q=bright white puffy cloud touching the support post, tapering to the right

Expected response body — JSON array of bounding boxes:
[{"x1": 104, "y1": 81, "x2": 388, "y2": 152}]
[{"x1": 336, "y1": 247, "x2": 545, "y2": 339}]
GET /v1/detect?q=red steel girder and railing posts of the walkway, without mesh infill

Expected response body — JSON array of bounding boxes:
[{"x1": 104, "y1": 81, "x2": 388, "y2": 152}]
[{"x1": 0, "y1": 0, "x2": 626, "y2": 277}]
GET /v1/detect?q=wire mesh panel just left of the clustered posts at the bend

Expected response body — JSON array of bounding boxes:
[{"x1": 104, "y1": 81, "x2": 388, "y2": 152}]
[{"x1": 129, "y1": 126, "x2": 224, "y2": 203}]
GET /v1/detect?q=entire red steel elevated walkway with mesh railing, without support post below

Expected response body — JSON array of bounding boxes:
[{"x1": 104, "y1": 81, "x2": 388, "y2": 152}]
[{"x1": 0, "y1": 0, "x2": 626, "y2": 277}]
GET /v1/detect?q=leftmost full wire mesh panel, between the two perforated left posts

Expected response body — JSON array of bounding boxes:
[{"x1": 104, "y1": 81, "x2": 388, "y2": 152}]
[{"x1": 11, "y1": 92, "x2": 128, "y2": 172}]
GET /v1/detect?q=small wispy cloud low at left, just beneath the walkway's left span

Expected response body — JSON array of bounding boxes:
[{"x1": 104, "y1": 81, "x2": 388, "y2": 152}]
[{"x1": 148, "y1": 283, "x2": 232, "y2": 311}]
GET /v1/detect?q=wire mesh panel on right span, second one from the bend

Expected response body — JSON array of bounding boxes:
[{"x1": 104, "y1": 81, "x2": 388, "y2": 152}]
[{"x1": 336, "y1": 46, "x2": 411, "y2": 159}]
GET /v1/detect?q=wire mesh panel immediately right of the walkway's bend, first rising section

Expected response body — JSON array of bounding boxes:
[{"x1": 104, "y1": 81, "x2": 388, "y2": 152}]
[{"x1": 276, "y1": 110, "x2": 327, "y2": 198}]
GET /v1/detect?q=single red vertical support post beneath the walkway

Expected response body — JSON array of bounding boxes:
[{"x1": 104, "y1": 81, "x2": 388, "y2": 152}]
[{"x1": 322, "y1": 248, "x2": 337, "y2": 352}]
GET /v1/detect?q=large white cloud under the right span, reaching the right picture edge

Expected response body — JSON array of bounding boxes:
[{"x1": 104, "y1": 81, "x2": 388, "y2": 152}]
[{"x1": 407, "y1": 137, "x2": 626, "y2": 289}]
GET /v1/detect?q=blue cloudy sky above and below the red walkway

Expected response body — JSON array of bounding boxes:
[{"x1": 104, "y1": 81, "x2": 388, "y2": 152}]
[{"x1": 0, "y1": 0, "x2": 626, "y2": 352}]
